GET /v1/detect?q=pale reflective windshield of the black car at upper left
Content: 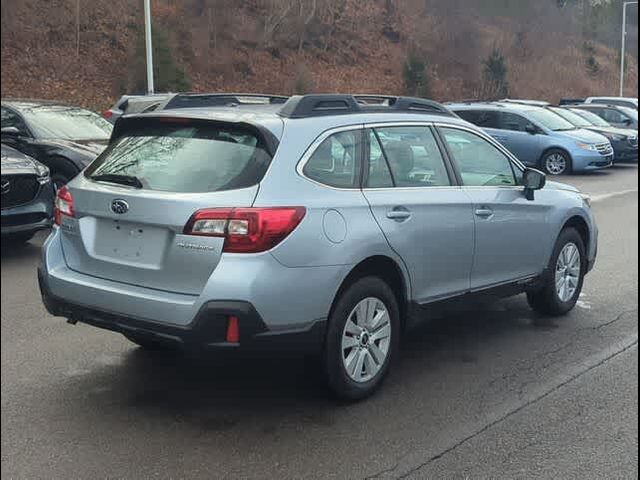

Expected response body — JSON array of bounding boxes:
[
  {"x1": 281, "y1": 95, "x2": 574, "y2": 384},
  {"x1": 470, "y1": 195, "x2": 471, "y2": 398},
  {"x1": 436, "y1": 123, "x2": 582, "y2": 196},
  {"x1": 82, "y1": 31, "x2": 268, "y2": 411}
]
[{"x1": 20, "y1": 105, "x2": 113, "y2": 140}]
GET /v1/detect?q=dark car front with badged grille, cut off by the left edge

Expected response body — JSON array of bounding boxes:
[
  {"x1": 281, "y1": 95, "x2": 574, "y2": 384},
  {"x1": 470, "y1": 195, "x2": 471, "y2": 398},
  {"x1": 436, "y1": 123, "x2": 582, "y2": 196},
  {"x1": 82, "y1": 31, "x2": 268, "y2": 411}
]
[{"x1": 0, "y1": 145, "x2": 54, "y2": 243}]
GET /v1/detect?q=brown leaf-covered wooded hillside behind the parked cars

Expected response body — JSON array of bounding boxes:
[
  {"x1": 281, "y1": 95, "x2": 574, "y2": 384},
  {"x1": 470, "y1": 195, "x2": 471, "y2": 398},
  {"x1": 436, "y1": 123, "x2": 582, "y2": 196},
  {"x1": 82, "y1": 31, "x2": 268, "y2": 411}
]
[{"x1": 2, "y1": 0, "x2": 638, "y2": 109}]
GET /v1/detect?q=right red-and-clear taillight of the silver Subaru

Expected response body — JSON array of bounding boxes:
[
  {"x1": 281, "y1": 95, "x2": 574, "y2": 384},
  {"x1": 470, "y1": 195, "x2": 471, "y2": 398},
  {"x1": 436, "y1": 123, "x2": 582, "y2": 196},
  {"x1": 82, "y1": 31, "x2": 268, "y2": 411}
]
[{"x1": 184, "y1": 207, "x2": 306, "y2": 253}]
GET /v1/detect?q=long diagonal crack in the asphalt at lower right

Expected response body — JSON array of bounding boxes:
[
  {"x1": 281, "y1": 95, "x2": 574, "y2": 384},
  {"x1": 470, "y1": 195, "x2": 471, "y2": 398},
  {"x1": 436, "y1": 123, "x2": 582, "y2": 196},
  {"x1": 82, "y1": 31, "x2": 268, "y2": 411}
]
[{"x1": 366, "y1": 334, "x2": 638, "y2": 480}]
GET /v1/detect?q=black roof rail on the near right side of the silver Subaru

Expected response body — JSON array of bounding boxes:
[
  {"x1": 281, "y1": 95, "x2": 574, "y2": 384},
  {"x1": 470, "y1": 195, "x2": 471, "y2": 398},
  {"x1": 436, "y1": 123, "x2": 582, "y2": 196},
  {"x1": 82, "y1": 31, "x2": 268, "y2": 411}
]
[{"x1": 280, "y1": 94, "x2": 454, "y2": 118}]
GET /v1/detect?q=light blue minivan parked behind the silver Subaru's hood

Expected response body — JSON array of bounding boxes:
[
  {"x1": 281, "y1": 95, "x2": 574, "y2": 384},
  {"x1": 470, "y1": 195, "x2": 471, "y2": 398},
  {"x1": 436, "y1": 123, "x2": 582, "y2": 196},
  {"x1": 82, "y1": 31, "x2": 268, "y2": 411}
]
[{"x1": 450, "y1": 101, "x2": 613, "y2": 175}]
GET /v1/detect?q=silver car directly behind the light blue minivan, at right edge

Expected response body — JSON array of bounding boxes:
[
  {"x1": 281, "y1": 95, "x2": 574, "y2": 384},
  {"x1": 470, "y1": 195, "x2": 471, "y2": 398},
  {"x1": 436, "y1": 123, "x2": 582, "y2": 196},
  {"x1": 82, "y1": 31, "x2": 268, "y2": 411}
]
[{"x1": 549, "y1": 107, "x2": 638, "y2": 163}]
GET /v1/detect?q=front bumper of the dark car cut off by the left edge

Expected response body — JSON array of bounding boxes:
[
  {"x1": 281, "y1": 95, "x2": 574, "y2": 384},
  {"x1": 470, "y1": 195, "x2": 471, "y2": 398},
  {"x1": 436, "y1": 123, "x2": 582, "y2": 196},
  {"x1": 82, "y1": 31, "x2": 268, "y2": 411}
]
[{"x1": 1, "y1": 183, "x2": 53, "y2": 235}]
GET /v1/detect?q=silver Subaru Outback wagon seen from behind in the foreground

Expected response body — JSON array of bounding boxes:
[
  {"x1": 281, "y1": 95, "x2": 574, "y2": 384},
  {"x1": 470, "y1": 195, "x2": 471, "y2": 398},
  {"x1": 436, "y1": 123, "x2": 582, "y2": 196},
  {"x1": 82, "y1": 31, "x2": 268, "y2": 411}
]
[{"x1": 39, "y1": 95, "x2": 597, "y2": 399}]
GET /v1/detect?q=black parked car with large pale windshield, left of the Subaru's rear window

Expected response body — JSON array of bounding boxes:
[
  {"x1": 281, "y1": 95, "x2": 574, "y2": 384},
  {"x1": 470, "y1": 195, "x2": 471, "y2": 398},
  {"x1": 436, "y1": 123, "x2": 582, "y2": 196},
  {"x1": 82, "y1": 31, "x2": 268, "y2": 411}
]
[{"x1": 1, "y1": 100, "x2": 113, "y2": 188}]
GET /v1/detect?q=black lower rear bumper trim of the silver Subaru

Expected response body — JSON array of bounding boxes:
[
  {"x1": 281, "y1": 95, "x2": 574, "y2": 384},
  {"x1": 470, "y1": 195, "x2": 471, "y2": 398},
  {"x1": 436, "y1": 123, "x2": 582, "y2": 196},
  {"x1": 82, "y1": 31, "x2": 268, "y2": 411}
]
[{"x1": 38, "y1": 267, "x2": 326, "y2": 353}]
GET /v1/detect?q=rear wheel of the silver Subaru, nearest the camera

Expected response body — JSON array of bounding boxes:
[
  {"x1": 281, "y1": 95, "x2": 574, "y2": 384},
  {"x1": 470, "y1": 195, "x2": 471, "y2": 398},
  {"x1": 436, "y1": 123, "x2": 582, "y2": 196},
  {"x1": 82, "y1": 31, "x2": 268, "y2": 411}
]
[{"x1": 323, "y1": 277, "x2": 401, "y2": 401}]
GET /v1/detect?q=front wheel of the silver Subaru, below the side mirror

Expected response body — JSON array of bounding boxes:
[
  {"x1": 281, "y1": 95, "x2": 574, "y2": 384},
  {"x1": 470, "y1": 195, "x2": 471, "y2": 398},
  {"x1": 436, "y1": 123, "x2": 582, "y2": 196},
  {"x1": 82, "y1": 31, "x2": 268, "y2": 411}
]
[{"x1": 527, "y1": 228, "x2": 587, "y2": 317}]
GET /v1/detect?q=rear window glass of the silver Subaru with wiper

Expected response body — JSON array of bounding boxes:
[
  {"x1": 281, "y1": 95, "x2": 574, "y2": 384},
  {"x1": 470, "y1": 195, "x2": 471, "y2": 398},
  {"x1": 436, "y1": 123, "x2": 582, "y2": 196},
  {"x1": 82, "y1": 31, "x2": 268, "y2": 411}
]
[{"x1": 86, "y1": 122, "x2": 271, "y2": 193}]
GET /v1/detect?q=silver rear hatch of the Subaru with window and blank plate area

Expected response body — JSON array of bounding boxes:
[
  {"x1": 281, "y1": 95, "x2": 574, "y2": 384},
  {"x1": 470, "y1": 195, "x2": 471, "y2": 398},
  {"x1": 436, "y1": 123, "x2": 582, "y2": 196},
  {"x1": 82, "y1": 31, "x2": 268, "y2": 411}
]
[{"x1": 61, "y1": 118, "x2": 272, "y2": 295}]
